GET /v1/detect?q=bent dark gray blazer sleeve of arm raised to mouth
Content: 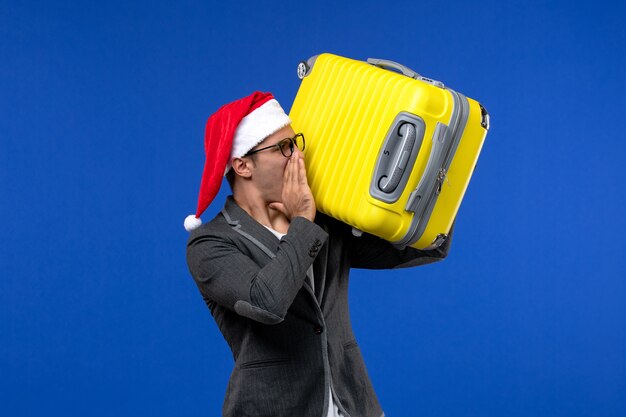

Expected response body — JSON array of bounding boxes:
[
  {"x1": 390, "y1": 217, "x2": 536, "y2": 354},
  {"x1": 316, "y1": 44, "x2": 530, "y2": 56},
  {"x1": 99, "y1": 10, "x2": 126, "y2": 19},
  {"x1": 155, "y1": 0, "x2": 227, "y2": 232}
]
[{"x1": 187, "y1": 217, "x2": 328, "y2": 324}]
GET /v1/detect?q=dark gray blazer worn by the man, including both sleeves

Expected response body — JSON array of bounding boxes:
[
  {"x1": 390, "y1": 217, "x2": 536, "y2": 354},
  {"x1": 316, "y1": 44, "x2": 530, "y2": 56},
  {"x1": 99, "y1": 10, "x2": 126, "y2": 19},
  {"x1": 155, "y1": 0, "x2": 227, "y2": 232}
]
[{"x1": 187, "y1": 197, "x2": 450, "y2": 417}]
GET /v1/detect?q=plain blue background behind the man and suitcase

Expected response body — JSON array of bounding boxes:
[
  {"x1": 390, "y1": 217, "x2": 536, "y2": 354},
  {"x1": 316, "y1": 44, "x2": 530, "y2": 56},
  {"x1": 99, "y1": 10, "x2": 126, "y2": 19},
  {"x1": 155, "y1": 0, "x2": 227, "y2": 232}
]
[{"x1": 0, "y1": 0, "x2": 626, "y2": 417}]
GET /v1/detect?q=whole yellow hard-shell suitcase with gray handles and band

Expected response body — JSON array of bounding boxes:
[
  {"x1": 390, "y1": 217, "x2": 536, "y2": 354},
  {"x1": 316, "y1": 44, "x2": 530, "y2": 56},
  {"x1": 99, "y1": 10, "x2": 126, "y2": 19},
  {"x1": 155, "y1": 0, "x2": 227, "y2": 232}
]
[{"x1": 289, "y1": 54, "x2": 489, "y2": 249}]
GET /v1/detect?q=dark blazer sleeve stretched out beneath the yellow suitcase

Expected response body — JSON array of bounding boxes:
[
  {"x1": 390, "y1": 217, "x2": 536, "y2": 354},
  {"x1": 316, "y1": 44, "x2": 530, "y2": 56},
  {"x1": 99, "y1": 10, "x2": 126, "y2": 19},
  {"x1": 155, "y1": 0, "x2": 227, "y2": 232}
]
[{"x1": 348, "y1": 224, "x2": 454, "y2": 269}]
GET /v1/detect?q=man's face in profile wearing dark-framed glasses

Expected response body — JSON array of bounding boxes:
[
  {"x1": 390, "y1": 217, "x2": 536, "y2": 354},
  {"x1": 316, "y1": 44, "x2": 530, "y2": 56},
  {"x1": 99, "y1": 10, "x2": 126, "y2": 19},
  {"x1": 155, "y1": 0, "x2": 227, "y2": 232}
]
[{"x1": 249, "y1": 126, "x2": 300, "y2": 203}]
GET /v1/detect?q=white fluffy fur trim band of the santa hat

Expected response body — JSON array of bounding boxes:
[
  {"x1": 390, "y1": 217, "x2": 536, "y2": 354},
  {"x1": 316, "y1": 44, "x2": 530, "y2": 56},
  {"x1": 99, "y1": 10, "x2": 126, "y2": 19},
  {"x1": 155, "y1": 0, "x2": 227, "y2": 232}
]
[{"x1": 224, "y1": 99, "x2": 291, "y2": 174}]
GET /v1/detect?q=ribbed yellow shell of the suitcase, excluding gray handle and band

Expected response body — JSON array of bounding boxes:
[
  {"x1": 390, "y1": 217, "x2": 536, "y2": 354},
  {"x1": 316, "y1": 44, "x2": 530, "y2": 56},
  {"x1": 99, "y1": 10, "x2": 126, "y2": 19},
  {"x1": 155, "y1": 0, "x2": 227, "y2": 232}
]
[{"x1": 289, "y1": 54, "x2": 486, "y2": 249}]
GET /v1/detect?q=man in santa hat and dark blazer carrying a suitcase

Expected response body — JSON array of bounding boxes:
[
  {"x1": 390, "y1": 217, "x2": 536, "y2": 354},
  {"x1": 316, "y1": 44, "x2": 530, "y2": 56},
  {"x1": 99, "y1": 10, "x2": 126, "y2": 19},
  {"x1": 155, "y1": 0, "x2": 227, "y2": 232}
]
[{"x1": 185, "y1": 92, "x2": 450, "y2": 417}]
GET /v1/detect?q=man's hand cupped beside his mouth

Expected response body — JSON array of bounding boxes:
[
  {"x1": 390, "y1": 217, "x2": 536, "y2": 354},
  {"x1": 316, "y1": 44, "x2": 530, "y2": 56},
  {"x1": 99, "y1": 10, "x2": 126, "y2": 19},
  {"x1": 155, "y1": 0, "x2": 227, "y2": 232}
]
[{"x1": 269, "y1": 151, "x2": 315, "y2": 221}]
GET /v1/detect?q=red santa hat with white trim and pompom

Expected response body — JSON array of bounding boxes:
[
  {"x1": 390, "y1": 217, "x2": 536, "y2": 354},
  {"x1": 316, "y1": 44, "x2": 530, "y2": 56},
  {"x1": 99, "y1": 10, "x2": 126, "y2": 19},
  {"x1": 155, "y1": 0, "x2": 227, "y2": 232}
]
[{"x1": 185, "y1": 91, "x2": 291, "y2": 232}]
